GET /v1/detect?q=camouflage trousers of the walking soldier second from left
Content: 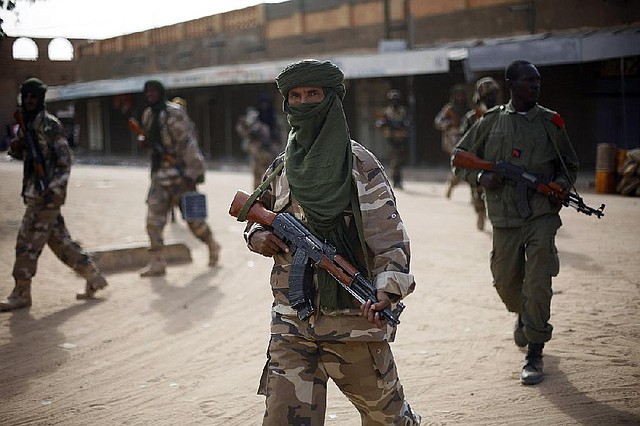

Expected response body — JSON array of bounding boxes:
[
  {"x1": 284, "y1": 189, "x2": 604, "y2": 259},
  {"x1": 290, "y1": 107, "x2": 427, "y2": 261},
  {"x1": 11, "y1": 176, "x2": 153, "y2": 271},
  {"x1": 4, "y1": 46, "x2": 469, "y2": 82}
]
[{"x1": 147, "y1": 179, "x2": 213, "y2": 252}]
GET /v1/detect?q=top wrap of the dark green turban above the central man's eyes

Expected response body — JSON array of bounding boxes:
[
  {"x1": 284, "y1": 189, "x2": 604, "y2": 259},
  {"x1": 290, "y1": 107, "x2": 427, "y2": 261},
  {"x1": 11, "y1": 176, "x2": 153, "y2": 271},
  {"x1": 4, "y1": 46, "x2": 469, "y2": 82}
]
[{"x1": 276, "y1": 59, "x2": 346, "y2": 104}]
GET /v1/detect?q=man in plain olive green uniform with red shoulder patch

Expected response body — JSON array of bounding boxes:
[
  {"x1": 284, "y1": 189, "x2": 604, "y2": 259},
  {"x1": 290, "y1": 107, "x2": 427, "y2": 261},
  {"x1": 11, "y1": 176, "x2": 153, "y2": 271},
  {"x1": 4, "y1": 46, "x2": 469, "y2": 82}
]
[{"x1": 456, "y1": 61, "x2": 578, "y2": 385}]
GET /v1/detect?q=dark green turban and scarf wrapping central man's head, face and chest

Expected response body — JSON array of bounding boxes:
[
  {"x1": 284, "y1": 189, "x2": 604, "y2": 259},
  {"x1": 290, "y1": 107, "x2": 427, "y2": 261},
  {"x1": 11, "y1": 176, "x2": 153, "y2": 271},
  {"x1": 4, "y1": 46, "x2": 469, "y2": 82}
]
[{"x1": 276, "y1": 60, "x2": 360, "y2": 309}]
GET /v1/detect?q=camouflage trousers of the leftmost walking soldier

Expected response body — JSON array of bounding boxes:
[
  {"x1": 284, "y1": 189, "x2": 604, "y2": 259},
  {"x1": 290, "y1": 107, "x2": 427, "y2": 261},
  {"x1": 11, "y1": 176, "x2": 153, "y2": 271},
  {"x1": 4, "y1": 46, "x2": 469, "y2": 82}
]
[{"x1": 13, "y1": 205, "x2": 97, "y2": 280}]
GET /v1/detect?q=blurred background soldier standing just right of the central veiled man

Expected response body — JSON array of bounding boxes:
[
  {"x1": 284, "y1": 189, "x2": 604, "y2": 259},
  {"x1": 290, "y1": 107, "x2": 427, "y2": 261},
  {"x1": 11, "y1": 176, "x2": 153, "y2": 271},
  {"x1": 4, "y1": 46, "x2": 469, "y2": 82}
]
[{"x1": 376, "y1": 89, "x2": 411, "y2": 189}]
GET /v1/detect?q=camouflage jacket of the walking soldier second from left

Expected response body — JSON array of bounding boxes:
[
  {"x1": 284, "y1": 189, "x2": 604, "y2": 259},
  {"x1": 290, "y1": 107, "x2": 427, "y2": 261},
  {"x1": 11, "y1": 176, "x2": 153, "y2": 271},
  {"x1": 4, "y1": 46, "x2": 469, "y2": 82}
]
[{"x1": 142, "y1": 102, "x2": 205, "y2": 185}]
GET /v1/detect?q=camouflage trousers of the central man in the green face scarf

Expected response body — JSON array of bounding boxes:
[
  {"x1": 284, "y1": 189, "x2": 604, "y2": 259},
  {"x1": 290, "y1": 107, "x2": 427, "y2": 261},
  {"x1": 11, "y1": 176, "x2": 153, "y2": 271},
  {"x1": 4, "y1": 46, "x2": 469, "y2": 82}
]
[{"x1": 258, "y1": 334, "x2": 420, "y2": 426}]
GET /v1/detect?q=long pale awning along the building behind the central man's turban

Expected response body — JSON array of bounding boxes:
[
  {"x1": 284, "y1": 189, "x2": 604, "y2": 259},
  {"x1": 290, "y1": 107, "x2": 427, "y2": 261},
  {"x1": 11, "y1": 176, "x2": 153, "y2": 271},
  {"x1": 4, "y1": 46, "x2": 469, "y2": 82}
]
[{"x1": 47, "y1": 48, "x2": 449, "y2": 102}]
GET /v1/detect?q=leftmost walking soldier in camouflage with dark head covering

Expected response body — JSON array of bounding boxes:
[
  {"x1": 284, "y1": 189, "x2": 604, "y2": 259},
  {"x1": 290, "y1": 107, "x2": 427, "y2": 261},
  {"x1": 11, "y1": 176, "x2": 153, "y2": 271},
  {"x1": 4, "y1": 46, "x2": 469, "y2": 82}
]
[{"x1": 0, "y1": 78, "x2": 107, "y2": 311}]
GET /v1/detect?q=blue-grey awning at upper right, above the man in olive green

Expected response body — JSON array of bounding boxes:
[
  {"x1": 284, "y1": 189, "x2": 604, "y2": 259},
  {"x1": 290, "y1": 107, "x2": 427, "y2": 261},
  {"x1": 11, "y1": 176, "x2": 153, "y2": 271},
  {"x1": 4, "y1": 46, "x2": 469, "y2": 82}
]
[{"x1": 467, "y1": 27, "x2": 640, "y2": 71}]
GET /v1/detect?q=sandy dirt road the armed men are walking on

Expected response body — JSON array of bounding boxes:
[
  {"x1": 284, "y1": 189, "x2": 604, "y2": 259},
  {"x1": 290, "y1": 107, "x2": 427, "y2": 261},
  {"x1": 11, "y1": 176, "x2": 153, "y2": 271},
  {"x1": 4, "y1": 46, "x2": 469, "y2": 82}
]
[{"x1": 0, "y1": 161, "x2": 640, "y2": 426}]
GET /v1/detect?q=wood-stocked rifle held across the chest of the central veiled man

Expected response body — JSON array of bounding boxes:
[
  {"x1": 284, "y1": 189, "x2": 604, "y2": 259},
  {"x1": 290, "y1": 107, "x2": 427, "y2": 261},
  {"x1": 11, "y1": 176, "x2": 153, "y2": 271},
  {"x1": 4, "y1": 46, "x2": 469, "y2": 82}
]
[{"x1": 229, "y1": 191, "x2": 404, "y2": 327}]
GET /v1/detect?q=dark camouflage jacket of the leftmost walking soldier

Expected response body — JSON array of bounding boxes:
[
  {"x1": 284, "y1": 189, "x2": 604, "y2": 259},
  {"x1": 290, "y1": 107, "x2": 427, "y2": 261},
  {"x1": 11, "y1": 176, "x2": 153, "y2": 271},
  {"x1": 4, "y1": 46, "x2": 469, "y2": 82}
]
[{"x1": 9, "y1": 110, "x2": 73, "y2": 207}]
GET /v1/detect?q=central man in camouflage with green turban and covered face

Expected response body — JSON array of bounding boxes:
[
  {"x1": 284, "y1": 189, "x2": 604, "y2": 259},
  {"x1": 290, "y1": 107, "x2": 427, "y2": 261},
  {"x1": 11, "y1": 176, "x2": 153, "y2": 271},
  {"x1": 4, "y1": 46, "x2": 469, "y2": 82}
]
[{"x1": 245, "y1": 60, "x2": 420, "y2": 426}]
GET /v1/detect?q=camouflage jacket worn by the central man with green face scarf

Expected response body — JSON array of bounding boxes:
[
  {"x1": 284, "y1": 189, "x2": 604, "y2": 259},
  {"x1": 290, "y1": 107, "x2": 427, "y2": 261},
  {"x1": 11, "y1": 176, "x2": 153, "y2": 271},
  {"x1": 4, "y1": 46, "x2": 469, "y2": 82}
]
[{"x1": 245, "y1": 141, "x2": 415, "y2": 341}]
